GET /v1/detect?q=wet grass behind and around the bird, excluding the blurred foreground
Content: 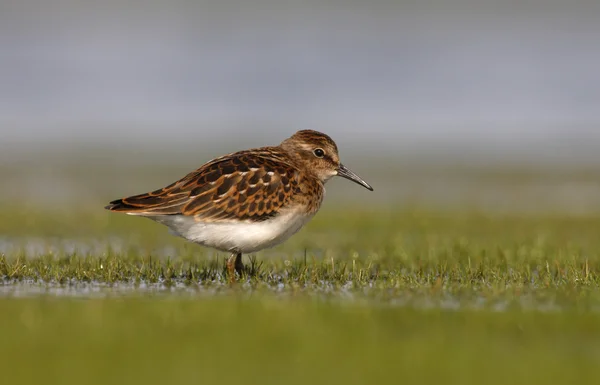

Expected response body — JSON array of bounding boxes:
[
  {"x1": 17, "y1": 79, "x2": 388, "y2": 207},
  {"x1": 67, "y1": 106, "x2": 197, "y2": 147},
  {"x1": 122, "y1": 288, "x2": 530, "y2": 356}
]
[{"x1": 0, "y1": 209, "x2": 600, "y2": 307}]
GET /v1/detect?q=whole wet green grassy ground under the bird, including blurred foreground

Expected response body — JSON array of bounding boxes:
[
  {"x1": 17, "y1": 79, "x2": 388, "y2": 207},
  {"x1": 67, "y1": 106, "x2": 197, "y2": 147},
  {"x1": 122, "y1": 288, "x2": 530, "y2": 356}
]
[{"x1": 0, "y1": 206, "x2": 600, "y2": 384}]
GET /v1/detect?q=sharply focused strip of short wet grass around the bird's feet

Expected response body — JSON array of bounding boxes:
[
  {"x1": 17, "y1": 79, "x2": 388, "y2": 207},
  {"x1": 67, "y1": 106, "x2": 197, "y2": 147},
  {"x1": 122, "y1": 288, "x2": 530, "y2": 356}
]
[{"x1": 0, "y1": 252, "x2": 600, "y2": 311}]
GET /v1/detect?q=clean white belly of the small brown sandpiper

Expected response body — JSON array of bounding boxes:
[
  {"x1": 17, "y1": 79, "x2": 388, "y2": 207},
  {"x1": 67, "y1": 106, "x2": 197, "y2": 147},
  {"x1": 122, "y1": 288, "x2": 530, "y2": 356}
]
[{"x1": 153, "y1": 212, "x2": 312, "y2": 253}]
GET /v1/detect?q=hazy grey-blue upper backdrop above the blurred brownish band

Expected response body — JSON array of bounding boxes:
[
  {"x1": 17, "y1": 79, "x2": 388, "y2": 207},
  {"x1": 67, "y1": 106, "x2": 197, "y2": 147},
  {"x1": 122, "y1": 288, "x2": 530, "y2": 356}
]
[{"x1": 0, "y1": 0, "x2": 600, "y2": 156}]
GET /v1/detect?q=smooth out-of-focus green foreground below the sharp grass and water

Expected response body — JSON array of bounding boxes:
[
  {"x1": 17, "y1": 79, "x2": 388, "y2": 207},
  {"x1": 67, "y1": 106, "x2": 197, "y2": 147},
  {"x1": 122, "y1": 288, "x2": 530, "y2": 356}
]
[{"x1": 0, "y1": 297, "x2": 600, "y2": 385}]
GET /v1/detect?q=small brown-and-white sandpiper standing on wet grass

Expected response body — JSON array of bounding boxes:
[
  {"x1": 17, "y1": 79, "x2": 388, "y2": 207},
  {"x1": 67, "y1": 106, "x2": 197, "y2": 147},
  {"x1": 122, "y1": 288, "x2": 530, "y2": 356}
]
[{"x1": 105, "y1": 130, "x2": 373, "y2": 275}]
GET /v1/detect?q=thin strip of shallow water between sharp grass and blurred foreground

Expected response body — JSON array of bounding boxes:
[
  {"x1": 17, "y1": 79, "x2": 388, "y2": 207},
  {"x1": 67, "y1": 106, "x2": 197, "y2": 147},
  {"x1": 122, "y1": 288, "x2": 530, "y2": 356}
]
[{"x1": 0, "y1": 277, "x2": 600, "y2": 312}]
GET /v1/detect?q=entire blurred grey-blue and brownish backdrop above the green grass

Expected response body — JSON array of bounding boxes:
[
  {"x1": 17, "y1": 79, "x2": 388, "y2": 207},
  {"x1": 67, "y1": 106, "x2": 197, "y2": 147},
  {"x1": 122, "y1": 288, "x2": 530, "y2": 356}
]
[{"x1": 0, "y1": 0, "x2": 600, "y2": 213}]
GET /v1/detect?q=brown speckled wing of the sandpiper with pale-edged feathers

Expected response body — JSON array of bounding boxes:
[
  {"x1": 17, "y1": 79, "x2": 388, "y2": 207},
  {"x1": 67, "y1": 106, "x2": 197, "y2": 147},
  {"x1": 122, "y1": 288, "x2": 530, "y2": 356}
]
[{"x1": 106, "y1": 148, "x2": 300, "y2": 222}]
